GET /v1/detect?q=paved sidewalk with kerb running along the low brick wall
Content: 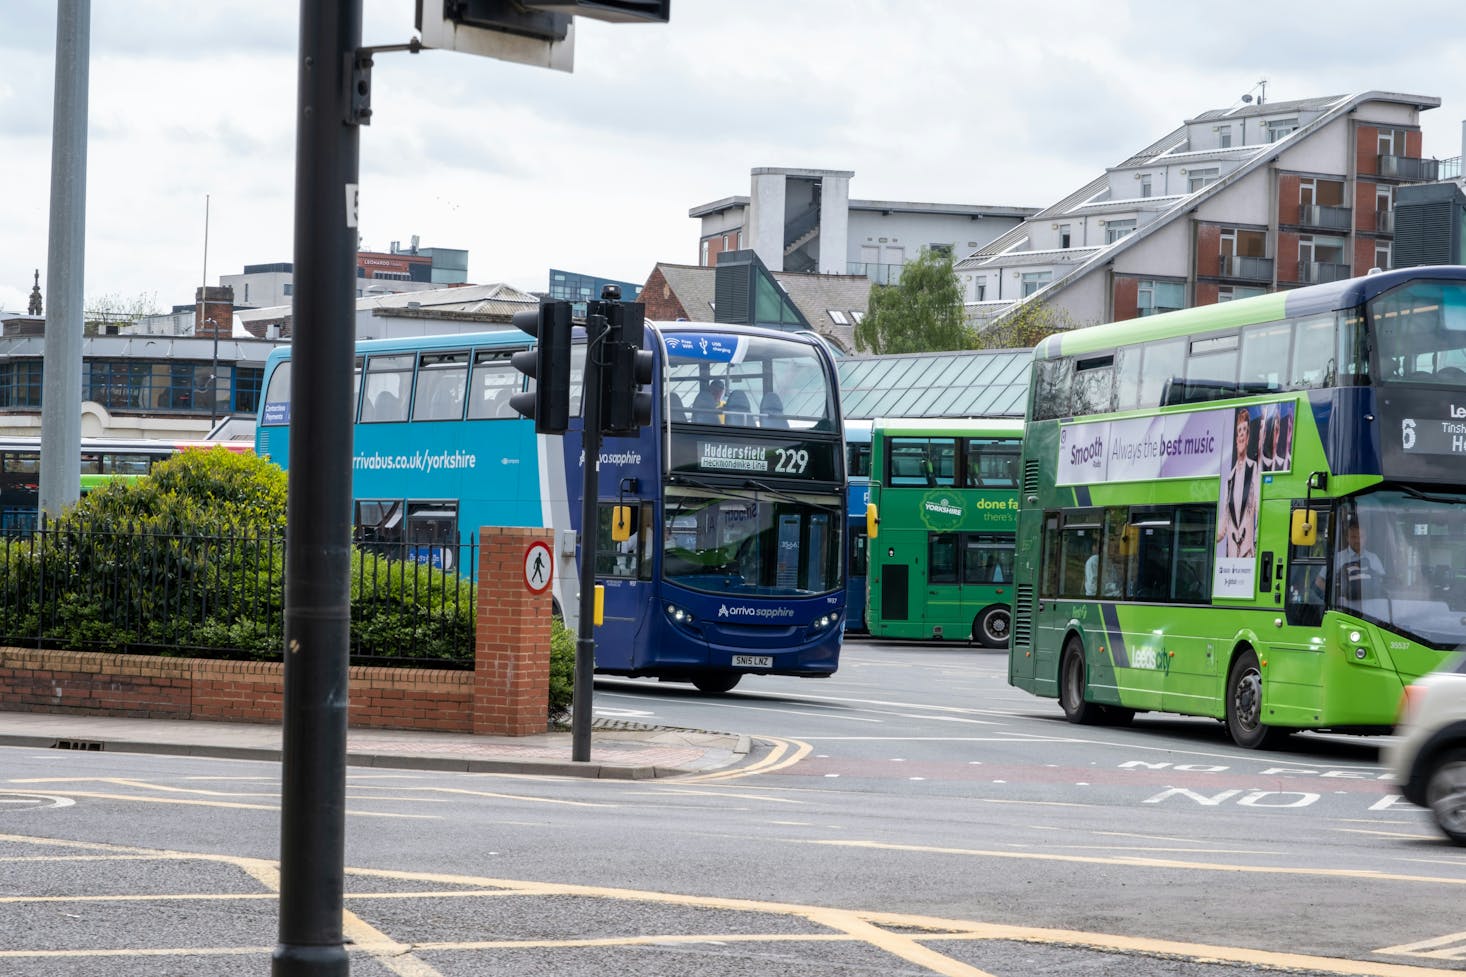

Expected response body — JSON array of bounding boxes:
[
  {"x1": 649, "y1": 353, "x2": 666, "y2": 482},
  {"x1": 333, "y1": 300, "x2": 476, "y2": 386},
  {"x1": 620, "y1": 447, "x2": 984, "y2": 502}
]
[{"x1": 0, "y1": 711, "x2": 749, "y2": 780}]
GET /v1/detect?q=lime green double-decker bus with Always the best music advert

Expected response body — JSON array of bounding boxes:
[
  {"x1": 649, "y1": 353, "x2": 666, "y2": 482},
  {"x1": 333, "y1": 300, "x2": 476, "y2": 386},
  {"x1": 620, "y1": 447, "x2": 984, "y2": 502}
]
[{"x1": 1009, "y1": 266, "x2": 1466, "y2": 748}]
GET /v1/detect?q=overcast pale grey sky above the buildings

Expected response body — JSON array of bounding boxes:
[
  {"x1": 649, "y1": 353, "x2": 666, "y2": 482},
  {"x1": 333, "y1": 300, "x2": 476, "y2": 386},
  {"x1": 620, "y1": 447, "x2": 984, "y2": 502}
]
[{"x1": 0, "y1": 0, "x2": 1466, "y2": 311}]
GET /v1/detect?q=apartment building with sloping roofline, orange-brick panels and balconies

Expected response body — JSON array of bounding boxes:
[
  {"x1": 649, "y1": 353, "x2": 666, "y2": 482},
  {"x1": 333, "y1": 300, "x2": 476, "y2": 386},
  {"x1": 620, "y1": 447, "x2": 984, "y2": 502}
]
[{"x1": 956, "y1": 91, "x2": 1441, "y2": 324}]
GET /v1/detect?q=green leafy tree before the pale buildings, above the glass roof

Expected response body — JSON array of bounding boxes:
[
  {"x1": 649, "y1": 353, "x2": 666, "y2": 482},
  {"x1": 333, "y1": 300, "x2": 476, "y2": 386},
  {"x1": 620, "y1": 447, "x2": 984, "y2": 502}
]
[{"x1": 855, "y1": 248, "x2": 972, "y2": 354}]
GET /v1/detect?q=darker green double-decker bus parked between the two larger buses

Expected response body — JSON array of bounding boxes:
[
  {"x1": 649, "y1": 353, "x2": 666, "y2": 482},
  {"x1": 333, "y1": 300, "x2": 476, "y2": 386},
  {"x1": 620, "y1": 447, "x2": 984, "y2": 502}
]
[{"x1": 865, "y1": 418, "x2": 1023, "y2": 648}]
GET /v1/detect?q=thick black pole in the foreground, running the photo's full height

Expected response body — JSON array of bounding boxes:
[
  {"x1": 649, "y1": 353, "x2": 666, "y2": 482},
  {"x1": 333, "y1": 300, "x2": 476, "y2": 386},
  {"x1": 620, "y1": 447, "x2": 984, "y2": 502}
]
[{"x1": 270, "y1": 0, "x2": 362, "y2": 977}]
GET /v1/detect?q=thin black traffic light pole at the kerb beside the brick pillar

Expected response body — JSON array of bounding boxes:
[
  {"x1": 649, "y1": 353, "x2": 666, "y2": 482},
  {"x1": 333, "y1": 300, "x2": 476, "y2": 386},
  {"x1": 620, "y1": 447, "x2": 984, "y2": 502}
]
[{"x1": 570, "y1": 312, "x2": 607, "y2": 763}]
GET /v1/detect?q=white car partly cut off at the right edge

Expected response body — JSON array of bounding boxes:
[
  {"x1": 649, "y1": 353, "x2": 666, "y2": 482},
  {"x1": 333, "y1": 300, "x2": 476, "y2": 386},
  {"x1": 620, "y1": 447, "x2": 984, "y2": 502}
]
[{"x1": 1385, "y1": 654, "x2": 1466, "y2": 845}]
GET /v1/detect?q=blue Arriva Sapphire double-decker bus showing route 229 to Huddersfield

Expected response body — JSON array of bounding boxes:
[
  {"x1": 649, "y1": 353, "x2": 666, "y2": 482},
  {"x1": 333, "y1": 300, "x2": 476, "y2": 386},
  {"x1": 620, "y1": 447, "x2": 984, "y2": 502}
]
[{"x1": 257, "y1": 323, "x2": 846, "y2": 692}]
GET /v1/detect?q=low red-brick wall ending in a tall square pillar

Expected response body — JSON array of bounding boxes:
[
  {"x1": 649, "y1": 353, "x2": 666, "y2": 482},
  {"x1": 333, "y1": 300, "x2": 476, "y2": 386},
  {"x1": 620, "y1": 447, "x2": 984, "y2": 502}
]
[{"x1": 0, "y1": 528, "x2": 551, "y2": 735}]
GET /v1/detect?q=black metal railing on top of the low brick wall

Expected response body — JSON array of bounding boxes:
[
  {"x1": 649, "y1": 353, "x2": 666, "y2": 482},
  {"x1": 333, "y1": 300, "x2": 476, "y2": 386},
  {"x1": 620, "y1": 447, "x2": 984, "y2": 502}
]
[{"x1": 0, "y1": 528, "x2": 476, "y2": 667}]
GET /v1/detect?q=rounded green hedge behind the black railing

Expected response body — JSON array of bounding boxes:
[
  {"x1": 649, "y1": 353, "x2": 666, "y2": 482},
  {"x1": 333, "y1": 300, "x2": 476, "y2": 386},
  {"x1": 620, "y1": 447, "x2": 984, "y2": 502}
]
[{"x1": 0, "y1": 447, "x2": 575, "y2": 714}]
